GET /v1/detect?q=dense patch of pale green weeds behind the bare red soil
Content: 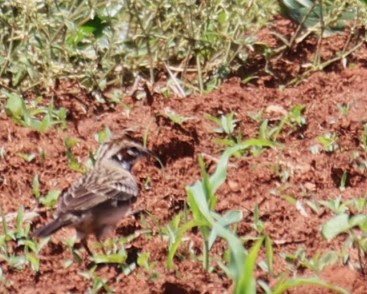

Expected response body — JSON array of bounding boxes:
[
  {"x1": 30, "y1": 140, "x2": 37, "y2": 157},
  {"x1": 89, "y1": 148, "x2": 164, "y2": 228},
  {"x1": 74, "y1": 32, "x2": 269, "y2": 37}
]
[{"x1": 0, "y1": 0, "x2": 277, "y2": 93}]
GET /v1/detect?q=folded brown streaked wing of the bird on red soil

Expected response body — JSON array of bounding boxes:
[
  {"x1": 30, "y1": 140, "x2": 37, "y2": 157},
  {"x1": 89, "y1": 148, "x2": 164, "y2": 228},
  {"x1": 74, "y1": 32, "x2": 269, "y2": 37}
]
[{"x1": 58, "y1": 170, "x2": 139, "y2": 212}]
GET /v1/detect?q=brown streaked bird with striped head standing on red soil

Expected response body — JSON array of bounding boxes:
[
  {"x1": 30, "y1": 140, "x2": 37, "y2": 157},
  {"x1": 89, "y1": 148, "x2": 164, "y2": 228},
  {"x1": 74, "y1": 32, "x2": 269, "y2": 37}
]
[{"x1": 32, "y1": 134, "x2": 150, "y2": 255}]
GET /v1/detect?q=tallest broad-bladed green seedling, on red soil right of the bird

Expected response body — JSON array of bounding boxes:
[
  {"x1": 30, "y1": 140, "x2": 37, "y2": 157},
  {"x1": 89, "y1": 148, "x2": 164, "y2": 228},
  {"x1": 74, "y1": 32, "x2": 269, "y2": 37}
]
[{"x1": 167, "y1": 139, "x2": 273, "y2": 293}]
